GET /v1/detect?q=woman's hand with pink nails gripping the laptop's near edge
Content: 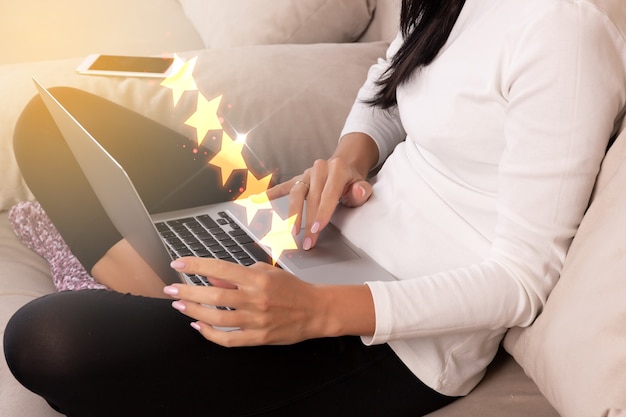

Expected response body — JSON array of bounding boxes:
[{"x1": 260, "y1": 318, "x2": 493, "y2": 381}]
[{"x1": 164, "y1": 258, "x2": 326, "y2": 347}]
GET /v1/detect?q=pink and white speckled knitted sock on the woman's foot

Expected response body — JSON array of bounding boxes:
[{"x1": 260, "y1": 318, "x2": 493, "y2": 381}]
[{"x1": 9, "y1": 201, "x2": 107, "y2": 291}]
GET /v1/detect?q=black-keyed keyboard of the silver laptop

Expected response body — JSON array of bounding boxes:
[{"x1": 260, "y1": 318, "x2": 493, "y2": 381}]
[{"x1": 155, "y1": 212, "x2": 272, "y2": 285}]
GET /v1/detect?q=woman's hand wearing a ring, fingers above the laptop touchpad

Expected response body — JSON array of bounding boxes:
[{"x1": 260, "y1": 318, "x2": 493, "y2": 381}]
[{"x1": 267, "y1": 134, "x2": 378, "y2": 250}]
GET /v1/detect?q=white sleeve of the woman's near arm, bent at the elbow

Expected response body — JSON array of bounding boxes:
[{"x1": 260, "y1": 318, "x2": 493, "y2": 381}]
[{"x1": 364, "y1": 2, "x2": 626, "y2": 344}]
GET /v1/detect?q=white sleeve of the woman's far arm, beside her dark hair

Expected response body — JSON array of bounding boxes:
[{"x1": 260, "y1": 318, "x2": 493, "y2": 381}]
[{"x1": 341, "y1": 34, "x2": 406, "y2": 165}]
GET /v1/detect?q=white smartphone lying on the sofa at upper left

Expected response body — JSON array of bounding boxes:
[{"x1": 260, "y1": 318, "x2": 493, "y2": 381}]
[{"x1": 76, "y1": 54, "x2": 180, "y2": 78}]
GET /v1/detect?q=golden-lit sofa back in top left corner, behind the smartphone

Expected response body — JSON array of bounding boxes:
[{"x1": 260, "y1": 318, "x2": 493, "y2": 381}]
[{"x1": 0, "y1": 0, "x2": 202, "y2": 64}]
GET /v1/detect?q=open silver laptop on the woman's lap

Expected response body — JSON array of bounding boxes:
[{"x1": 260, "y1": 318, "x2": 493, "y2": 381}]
[{"x1": 33, "y1": 78, "x2": 395, "y2": 285}]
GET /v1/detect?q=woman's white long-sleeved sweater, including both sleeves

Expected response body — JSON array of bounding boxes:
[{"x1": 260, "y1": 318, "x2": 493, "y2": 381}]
[{"x1": 334, "y1": 0, "x2": 626, "y2": 395}]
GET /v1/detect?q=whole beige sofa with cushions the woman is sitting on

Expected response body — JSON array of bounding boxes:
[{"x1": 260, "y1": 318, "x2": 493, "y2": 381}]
[{"x1": 0, "y1": 0, "x2": 626, "y2": 417}]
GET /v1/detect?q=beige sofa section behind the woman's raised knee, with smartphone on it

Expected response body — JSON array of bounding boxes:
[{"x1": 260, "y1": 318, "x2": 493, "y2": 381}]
[{"x1": 0, "y1": 42, "x2": 387, "y2": 210}]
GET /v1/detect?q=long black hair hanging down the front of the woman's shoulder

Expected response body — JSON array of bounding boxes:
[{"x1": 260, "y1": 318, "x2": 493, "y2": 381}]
[{"x1": 366, "y1": 0, "x2": 465, "y2": 109}]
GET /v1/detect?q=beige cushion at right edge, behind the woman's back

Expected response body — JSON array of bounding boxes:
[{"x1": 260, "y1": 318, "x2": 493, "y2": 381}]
[{"x1": 505, "y1": 127, "x2": 626, "y2": 417}]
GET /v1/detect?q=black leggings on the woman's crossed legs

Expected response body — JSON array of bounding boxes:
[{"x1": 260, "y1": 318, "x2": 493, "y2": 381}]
[{"x1": 4, "y1": 89, "x2": 453, "y2": 417}]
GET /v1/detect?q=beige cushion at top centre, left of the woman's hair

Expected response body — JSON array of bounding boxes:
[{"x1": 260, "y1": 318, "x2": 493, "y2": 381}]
[{"x1": 180, "y1": 0, "x2": 376, "y2": 48}]
